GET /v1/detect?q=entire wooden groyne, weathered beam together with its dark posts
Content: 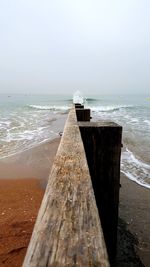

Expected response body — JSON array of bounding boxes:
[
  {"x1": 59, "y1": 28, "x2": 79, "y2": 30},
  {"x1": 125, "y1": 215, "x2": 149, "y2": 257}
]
[{"x1": 23, "y1": 107, "x2": 121, "y2": 267}]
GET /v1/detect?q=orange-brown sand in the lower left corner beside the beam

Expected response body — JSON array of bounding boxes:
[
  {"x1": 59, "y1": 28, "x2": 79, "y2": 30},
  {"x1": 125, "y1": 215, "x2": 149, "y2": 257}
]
[{"x1": 0, "y1": 178, "x2": 43, "y2": 267}]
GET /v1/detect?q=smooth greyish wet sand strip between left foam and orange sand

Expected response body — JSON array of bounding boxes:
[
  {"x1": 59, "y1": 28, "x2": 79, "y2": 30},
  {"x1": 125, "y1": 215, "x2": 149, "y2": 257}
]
[{"x1": 0, "y1": 137, "x2": 60, "y2": 182}]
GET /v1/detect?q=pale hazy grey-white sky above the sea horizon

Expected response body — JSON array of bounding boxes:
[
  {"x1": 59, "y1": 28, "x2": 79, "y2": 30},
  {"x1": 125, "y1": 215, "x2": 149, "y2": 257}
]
[{"x1": 0, "y1": 0, "x2": 150, "y2": 94}]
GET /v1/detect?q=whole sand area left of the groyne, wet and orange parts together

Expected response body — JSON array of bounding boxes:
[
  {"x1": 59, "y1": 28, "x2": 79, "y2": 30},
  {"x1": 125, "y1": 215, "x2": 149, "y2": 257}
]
[{"x1": 0, "y1": 138, "x2": 60, "y2": 267}]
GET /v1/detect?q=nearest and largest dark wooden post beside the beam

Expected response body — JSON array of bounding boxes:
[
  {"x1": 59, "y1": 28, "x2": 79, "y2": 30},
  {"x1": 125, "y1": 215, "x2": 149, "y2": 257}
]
[{"x1": 78, "y1": 122, "x2": 122, "y2": 263}]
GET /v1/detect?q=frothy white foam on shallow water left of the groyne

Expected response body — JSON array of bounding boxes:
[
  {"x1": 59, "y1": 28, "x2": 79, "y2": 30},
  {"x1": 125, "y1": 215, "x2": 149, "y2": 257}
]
[{"x1": 0, "y1": 108, "x2": 66, "y2": 158}]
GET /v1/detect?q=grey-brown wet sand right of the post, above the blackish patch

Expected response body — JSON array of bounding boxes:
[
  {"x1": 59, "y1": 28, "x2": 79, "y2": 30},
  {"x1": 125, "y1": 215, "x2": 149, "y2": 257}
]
[{"x1": 119, "y1": 175, "x2": 150, "y2": 267}]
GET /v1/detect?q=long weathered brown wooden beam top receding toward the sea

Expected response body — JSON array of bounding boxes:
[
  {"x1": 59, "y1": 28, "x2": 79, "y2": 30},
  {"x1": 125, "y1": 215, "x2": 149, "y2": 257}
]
[{"x1": 23, "y1": 108, "x2": 109, "y2": 267}]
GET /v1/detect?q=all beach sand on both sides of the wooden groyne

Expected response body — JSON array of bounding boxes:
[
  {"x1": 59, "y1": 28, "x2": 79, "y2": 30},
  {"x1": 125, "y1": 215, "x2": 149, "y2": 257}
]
[{"x1": 0, "y1": 139, "x2": 150, "y2": 267}]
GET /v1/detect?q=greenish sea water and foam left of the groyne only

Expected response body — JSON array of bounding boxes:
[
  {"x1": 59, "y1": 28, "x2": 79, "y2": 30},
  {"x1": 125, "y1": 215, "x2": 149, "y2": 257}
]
[{"x1": 0, "y1": 94, "x2": 69, "y2": 158}]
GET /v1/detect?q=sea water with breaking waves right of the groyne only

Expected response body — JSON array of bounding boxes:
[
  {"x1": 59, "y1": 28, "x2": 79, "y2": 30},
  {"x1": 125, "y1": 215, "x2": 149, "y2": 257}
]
[{"x1": 87, "y1": 95, "x2": 150, "y2": 188}]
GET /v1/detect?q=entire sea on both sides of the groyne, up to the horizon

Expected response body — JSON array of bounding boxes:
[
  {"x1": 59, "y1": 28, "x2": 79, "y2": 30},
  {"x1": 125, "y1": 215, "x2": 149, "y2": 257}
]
[{"x1": 0, "y1": 92, "x2": 150, "y2": 188}]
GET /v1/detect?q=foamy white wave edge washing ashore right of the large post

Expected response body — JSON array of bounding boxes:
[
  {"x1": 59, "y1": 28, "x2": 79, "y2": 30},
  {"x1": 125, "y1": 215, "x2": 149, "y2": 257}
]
[{"x1": 121, "y1": 148, "x2": 150, "y2": 188}]
